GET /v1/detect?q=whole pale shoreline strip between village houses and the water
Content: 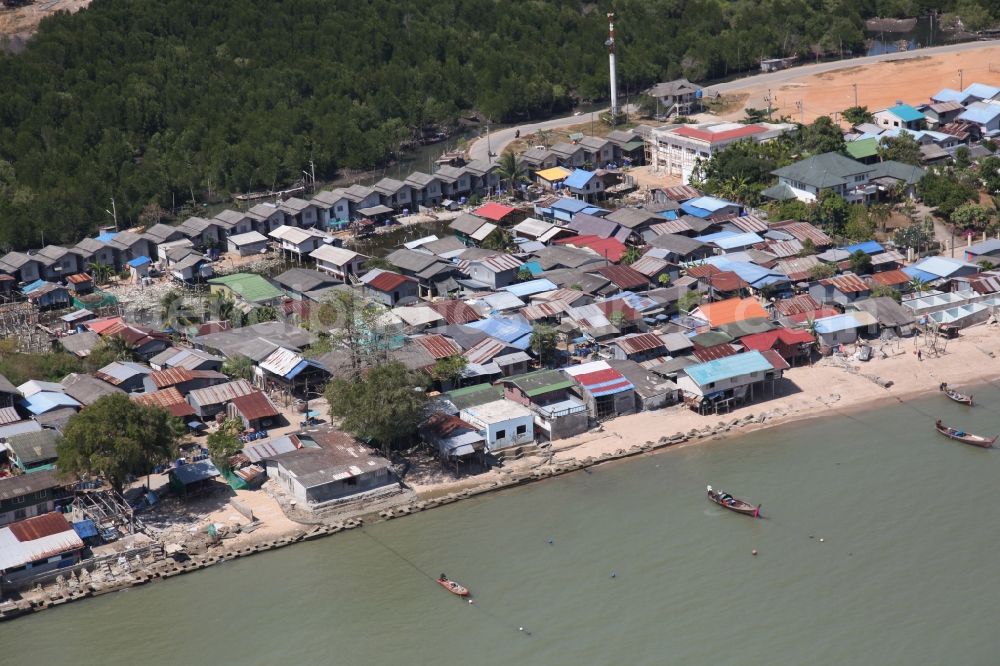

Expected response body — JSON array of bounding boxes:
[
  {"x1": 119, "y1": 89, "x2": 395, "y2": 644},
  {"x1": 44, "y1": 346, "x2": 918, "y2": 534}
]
[{"x1": 0, "y1": 325, "x2": 1000, "y2": 621}]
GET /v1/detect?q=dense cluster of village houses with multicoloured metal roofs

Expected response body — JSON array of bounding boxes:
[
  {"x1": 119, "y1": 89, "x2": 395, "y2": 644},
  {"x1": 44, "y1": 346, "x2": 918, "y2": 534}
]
[{"x1": 0, "y1": 76, "x2": 1000, "y2": 593}]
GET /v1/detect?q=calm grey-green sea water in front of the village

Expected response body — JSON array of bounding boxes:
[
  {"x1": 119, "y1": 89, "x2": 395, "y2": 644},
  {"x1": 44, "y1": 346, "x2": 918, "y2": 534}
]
[{"x1": 0, "y1": 388, "x2": 1000, "y2": 666}]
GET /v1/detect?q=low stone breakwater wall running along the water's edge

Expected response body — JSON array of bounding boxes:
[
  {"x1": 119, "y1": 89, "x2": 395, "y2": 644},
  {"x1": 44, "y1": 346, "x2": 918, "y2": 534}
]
[{"x1": 0, "y1": 396, "x2": 839, "y2": 621}]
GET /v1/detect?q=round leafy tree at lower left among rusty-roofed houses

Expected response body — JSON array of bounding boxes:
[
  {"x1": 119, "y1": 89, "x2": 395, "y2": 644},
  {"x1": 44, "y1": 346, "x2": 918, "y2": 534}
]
[{"x1": 56, "y1": 393, "x2": 183, "y2": 491}]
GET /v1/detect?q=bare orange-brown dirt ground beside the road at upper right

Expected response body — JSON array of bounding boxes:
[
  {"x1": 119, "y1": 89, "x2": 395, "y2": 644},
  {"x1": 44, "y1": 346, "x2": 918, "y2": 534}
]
[{"x1": 711, "y1": 42, "x2": 1000, "y2": 122}]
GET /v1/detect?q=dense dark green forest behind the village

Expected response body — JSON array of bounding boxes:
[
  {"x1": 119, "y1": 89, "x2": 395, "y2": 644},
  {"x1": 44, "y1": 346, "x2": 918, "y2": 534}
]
[{"x1": 0, "y1": 0, "x2": 1000, "y2": 248}]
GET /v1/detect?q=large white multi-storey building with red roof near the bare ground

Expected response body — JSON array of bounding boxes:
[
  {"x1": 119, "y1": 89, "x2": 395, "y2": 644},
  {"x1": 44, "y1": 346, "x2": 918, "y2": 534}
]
[{"x1": 648, "y1": 122, "x2": 795, "y2": 185}]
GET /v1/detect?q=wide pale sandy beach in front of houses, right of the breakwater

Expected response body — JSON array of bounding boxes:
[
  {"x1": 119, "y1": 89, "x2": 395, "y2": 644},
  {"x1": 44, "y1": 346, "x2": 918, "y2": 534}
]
[{"x1": 408, "y1": 325, "x2": 1000, "y2": 499}]
